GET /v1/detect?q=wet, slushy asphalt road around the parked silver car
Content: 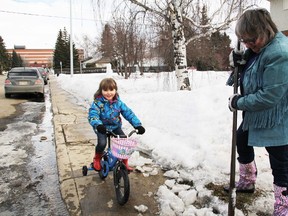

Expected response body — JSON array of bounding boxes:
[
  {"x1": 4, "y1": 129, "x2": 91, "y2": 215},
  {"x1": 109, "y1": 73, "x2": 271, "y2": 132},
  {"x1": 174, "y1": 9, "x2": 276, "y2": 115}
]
[{"x1": 0, "y1": 75, "x2": 69, "y2": 216}]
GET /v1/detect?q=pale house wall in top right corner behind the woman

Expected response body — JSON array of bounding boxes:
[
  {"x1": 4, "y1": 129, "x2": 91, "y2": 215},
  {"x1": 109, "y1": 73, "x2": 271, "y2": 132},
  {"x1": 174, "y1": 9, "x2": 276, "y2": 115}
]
[{"x1": 268, "y1": 0, "x2": 288, "y2": 36}]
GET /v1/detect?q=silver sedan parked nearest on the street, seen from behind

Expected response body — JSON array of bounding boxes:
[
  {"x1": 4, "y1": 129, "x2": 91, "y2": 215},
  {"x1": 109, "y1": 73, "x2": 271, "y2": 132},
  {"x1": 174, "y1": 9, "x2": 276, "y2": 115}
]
[{"x1": 4, "y1": 67, "x2": 44, "y2": 99}]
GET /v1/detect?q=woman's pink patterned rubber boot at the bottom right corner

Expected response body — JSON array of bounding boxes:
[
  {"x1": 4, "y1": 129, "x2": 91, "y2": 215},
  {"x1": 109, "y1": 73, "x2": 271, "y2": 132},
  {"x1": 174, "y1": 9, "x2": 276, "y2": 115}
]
[{"x1": 273, "y1": 184, "x2": 288, "y2": 216}]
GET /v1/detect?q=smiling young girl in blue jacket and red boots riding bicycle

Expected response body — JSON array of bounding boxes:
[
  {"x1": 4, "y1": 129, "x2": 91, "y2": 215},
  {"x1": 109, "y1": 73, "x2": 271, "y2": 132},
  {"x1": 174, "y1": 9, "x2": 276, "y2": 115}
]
[{"x1": 88, "y1": 78, "x2": 145, "y2": 171}]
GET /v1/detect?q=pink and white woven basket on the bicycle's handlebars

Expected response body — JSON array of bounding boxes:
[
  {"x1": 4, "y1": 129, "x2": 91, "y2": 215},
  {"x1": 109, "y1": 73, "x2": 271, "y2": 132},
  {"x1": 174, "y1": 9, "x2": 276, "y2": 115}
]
[{"x1": 111, "y1": 137, "x2": 137, "y2": 159}]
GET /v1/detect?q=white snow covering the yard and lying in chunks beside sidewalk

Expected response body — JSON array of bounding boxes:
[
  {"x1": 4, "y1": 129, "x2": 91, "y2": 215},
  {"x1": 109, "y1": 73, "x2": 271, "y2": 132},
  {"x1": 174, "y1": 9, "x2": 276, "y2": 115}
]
[{"x1": 56, "y1": 71, "x2": 274, "y2": 216}]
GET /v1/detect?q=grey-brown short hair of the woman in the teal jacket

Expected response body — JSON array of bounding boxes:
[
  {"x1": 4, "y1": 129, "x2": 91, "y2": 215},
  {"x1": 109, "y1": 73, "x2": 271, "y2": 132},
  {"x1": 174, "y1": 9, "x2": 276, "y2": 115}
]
[{"x1": 235, "y1": 8, "x2": 278, "y2": 42}]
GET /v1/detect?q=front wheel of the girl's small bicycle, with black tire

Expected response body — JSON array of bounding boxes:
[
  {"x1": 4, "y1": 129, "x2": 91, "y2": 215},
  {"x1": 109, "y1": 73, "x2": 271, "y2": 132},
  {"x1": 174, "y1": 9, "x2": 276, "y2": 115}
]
[{"x1": 114, "y1": 163, "x2": 130, "y2": 205}]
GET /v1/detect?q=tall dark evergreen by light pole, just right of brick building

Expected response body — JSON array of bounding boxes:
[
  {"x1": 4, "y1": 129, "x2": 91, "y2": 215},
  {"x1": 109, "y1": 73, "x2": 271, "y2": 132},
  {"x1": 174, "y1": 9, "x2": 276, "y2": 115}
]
[{"x1": 53, "y1": 28, "x2": 79, "y2": 69}]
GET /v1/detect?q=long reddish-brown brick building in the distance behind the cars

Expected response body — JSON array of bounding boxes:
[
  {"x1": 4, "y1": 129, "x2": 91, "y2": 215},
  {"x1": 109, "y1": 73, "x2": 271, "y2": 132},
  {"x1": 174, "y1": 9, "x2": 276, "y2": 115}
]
[{"x1": 7, "y1": 46, "x2": 84, "y2": 68}]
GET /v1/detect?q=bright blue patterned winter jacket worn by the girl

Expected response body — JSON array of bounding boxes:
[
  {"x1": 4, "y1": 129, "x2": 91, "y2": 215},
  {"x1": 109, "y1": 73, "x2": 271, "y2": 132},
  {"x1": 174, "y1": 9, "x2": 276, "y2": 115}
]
[{"x1": 88, "y1": 96, "x2": 141, "y2": 131}]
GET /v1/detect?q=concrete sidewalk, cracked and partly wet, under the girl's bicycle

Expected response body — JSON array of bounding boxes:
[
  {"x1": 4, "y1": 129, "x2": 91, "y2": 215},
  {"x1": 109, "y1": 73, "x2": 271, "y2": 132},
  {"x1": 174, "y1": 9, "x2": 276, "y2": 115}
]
[{"x1": 49, "y1": 76, "x2": 164, "y2": 216}]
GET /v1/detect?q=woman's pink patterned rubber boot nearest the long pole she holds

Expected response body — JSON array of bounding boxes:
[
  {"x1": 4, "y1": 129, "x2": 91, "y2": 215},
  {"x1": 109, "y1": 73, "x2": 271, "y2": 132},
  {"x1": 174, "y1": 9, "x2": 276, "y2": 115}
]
[{"x1": 224, "y1": 161, "x2": 257, "y2": 193}]
